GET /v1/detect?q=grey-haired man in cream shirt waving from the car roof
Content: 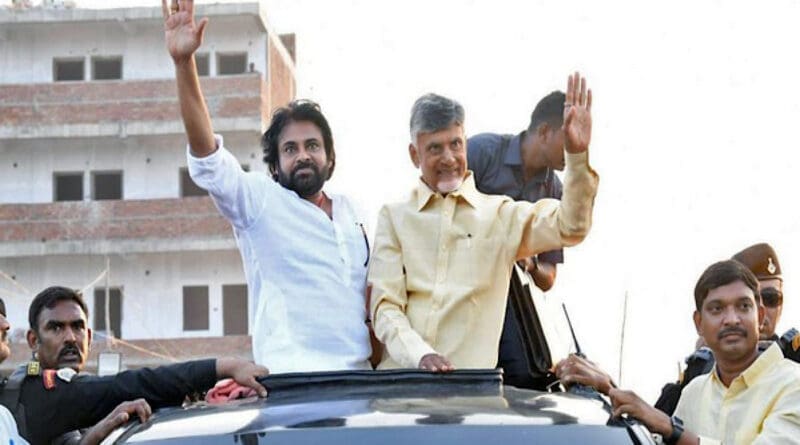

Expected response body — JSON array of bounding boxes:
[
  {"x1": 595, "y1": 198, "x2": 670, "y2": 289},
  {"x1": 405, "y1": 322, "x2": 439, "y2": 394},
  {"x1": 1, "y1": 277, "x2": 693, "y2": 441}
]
[{"x1": 368, "y1": 73, "x2": 597, "y2": 372}]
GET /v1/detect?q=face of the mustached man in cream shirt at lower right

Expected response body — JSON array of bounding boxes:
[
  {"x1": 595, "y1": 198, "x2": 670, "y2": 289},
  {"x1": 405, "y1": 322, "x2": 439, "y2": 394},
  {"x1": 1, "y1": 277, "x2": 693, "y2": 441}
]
[{"x1": 694, "y1": 281, "x2": 764, "y2": 362}]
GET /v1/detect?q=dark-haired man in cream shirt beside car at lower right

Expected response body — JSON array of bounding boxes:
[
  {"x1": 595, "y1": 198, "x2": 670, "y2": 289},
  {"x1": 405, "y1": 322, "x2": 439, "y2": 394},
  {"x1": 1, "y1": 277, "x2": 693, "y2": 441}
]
[{"x1": 555, "y1": 260, "x2": 800, "y2": 445}]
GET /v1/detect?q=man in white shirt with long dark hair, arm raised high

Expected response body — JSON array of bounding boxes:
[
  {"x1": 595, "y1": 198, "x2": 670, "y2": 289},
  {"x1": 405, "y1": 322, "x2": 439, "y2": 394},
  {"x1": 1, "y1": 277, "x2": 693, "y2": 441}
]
[{"x1": 162, "y1": 0, "x2": 371, "y2": 373}]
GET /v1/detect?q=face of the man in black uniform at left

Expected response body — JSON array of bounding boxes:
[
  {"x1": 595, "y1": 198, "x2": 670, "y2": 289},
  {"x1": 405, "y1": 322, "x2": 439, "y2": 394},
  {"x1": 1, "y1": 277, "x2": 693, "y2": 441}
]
[{"x1": 28, "y1": 301, "x2": 92, "y2": 372}]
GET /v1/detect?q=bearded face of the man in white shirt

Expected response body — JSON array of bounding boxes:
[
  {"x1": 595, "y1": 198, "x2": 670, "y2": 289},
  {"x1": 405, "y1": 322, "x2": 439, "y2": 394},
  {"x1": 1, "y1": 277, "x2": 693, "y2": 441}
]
[{"x1": 278, "y1": 121, "x2": 330, "y2": 198}]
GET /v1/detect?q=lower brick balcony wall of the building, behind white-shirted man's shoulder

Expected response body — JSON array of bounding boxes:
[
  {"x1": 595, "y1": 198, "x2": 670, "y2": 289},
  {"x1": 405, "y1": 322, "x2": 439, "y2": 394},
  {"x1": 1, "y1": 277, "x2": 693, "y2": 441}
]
[{"x1": 0, "y1": 197, "x2": 236, "y2": 257}]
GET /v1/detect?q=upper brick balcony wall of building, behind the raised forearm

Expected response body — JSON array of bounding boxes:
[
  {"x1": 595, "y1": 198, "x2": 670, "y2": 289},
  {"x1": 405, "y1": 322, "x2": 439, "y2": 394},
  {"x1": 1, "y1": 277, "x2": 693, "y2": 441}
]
[{"x1": 0, "y1": 72, "x2": 274, "y2": 139}]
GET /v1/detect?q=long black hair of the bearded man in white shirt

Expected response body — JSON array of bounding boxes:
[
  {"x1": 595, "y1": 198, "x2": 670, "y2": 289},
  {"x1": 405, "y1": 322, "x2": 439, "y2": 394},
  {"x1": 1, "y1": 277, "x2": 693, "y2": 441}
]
[{"x1": 261, "y1": 99, "x2": 336, "y2": 180}]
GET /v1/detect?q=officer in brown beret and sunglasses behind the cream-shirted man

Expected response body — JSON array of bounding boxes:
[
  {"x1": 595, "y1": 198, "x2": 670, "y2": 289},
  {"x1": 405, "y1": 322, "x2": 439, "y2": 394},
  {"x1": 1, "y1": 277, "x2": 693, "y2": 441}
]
[{"x1": 655, "y1": 243, "x2": 800, "y2": 416}]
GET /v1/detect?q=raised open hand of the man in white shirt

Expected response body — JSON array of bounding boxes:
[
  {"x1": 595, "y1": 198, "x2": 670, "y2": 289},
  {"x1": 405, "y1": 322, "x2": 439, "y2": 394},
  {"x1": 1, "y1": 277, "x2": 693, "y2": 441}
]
[{"x1": 161, "y1": 0, "x2": 208, "y2": 64}]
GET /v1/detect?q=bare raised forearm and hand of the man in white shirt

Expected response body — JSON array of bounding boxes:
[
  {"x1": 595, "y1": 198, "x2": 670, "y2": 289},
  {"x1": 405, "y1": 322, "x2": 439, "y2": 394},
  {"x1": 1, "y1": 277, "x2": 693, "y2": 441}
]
[{"x1": 161, "y1": 0, "x2": 217, "y2": 158}]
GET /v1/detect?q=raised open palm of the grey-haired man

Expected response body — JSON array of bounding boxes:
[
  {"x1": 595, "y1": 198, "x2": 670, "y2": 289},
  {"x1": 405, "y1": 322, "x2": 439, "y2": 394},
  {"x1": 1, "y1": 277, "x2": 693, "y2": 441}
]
[{"x1": 564, "y1": 71, "x2": 592, "y2": 153}]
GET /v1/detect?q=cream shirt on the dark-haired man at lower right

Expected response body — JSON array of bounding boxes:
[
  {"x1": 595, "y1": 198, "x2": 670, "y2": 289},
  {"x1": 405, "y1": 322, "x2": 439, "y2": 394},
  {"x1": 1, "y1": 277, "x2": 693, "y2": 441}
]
[{"x1": 675, "y1": 344, "x2": 800, "y2": 445}]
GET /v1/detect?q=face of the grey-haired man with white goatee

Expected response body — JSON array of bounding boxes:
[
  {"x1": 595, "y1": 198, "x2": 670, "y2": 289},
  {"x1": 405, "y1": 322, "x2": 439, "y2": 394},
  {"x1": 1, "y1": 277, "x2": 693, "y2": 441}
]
[{"x1": 408, "y1": 124, "x2": 467, "y2": 193}]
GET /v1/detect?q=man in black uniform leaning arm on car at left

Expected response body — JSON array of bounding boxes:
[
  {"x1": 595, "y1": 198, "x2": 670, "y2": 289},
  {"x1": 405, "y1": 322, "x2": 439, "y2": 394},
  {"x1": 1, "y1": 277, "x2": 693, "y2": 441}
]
[{"x1": 3, "y1": 286, "x2": 267, "y2": 445}]
